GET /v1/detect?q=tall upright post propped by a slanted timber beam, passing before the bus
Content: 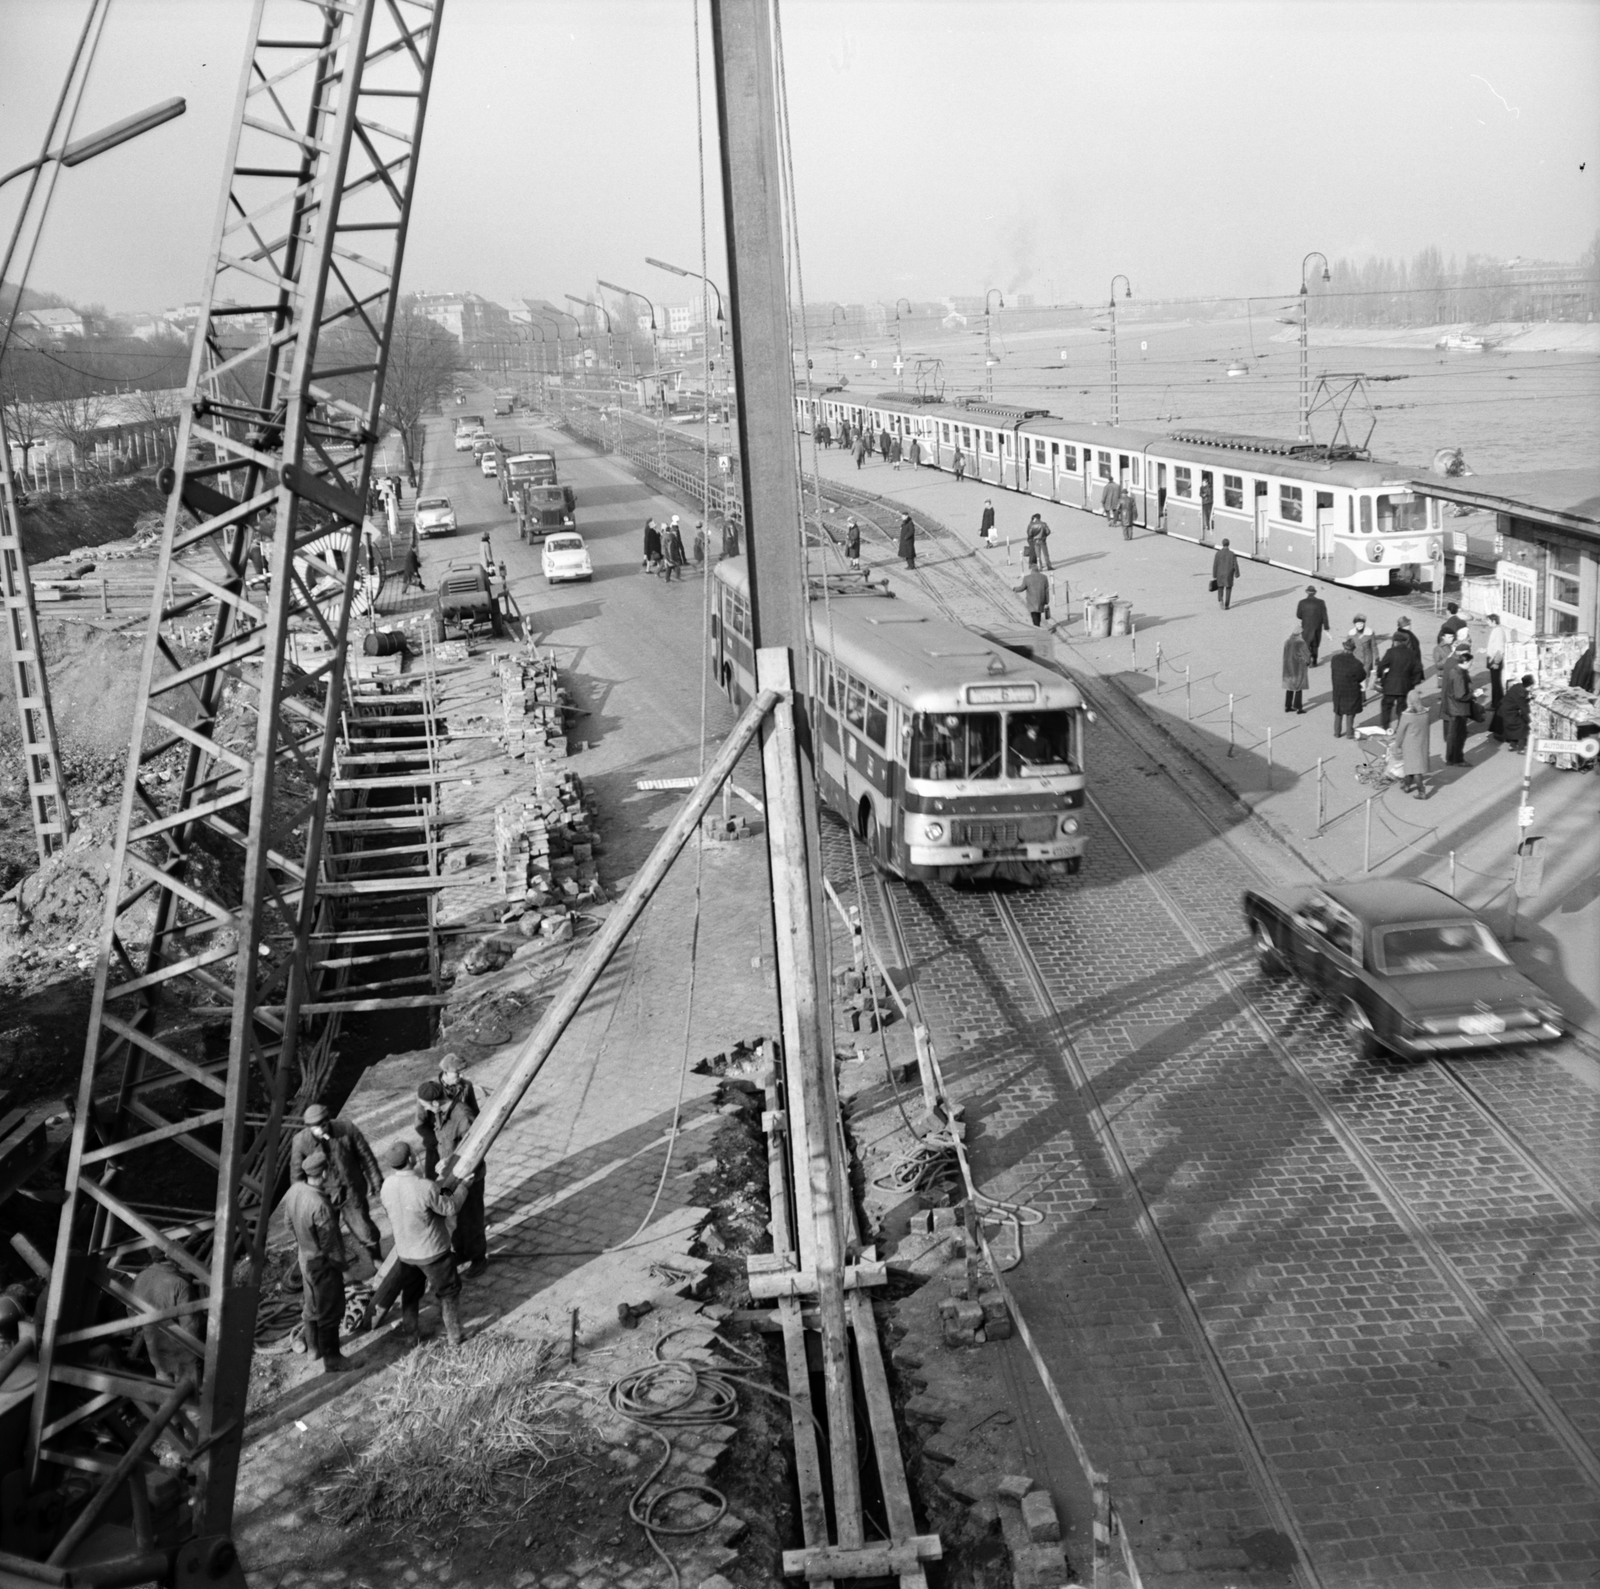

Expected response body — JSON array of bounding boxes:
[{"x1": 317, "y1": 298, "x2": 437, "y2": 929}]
[{"x1": 710, "y1": 0, "x2": 862, "y2": 1549}]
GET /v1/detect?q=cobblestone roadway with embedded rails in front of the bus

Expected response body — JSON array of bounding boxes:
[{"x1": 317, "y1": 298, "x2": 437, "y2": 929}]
[{"x1": 812, "y1": 488, "x2": 1600, "y2": 1586}]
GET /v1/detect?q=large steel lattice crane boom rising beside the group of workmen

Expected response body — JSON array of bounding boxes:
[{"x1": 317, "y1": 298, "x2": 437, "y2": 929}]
[{"x1": 29, "y1": 0, "x2": 443, "y2": 1539}]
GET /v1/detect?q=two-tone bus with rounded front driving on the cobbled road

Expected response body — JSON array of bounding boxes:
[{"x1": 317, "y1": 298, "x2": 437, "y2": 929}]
[{"x1": 710, "y1": 557, "x2": 1085, "y2": 882}]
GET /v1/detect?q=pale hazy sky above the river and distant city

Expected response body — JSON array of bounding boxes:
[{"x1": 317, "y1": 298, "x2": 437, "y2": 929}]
[{"x1": 0, "y1": 0, "x2": 1600, "y2": 309}]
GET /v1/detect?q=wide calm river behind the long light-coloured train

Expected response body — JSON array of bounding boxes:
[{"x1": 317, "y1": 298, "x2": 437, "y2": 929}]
[{"x1": 838, "y1": 315, "x2": 1600, "y2": 474}]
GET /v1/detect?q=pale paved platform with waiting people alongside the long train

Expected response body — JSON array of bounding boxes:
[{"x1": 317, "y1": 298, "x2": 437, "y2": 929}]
[{"x1": 805, "y1": 442, "x2": 1600, "y2": 1049}]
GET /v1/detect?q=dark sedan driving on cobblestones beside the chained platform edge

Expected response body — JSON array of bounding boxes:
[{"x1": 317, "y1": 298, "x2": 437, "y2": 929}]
[{"x1": 1245, "y1": 877, "x2": 1563, "y2": 1059}]
